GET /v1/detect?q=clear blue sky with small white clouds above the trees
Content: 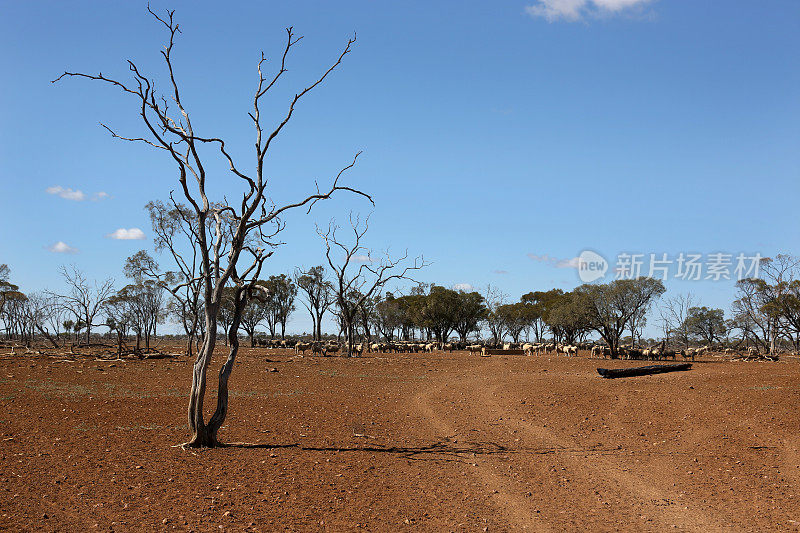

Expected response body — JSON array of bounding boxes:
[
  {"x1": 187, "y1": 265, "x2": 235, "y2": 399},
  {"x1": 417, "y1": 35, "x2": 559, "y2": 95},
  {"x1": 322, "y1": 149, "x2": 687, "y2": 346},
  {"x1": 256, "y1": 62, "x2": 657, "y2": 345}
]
[{"x1": 0, "y1": 0, "x2": 800, "y2": 336}]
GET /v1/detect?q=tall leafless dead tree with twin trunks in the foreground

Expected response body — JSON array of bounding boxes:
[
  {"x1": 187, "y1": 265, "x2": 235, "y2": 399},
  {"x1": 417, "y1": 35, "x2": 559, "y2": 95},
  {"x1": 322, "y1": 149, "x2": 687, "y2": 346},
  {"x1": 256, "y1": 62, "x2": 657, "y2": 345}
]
[{"x1": 54, "y1": 7, "x2": 372, "y2": 447}]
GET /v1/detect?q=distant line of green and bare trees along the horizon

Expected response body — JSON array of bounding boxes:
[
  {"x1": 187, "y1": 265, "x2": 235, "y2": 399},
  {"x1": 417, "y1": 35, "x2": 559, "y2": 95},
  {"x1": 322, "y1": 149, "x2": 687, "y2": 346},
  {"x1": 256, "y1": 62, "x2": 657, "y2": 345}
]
[{"x1": 0, "y1": 255, "x2": 800, "y2": 362}]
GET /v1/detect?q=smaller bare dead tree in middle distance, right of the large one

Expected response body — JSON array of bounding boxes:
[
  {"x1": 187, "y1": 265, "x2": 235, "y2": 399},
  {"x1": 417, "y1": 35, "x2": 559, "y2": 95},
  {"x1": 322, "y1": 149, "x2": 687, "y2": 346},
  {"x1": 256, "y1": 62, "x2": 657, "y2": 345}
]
[{"x1": 317, "y1": 215, "x2": 428, "y2": 357}]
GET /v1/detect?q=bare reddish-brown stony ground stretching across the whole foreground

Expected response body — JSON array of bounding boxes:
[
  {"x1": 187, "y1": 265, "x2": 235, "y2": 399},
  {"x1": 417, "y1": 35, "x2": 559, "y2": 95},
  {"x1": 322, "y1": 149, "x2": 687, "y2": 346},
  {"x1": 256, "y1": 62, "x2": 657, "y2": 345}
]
[{"x1": 0, "y1": 350, "x2": 800, "y2": 531}]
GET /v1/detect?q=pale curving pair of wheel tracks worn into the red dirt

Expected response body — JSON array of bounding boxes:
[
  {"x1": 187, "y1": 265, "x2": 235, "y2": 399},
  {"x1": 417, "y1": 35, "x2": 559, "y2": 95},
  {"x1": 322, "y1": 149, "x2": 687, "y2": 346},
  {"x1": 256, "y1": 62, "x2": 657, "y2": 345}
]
[{"x1": 414, "y1": 370, "x2": 726, "y2": 532}]
